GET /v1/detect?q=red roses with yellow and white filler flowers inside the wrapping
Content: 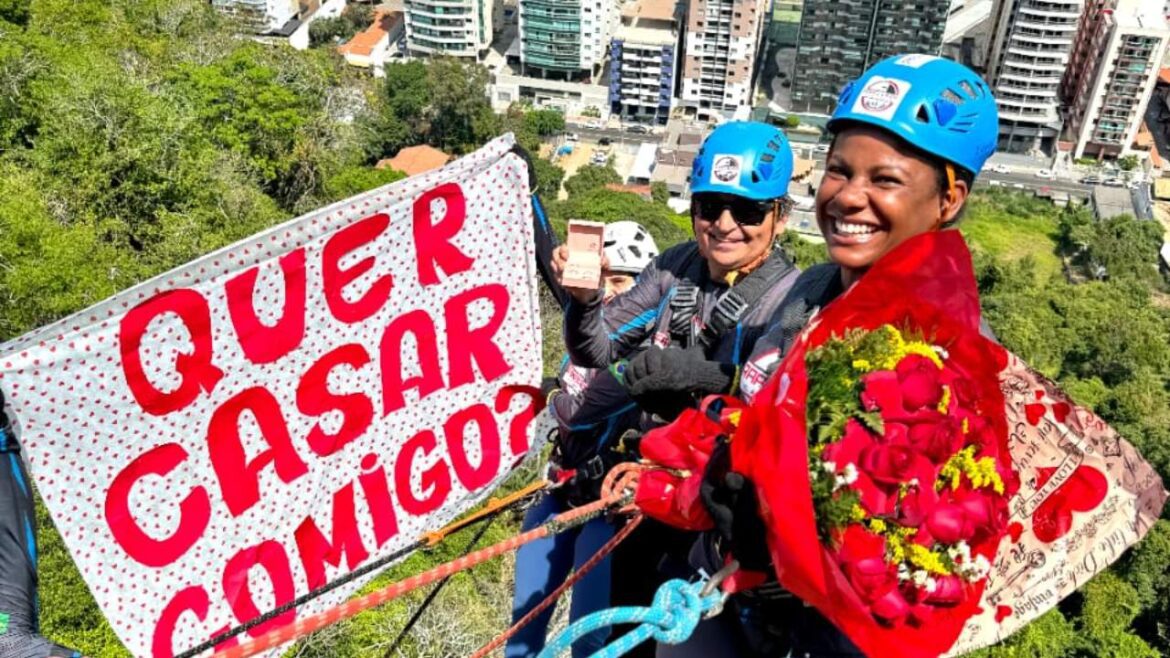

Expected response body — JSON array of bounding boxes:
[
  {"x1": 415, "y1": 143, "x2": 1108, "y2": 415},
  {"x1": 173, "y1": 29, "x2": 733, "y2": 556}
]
[{"x1": 805, "y1": 324, "x2": 1019, "y2": 628}]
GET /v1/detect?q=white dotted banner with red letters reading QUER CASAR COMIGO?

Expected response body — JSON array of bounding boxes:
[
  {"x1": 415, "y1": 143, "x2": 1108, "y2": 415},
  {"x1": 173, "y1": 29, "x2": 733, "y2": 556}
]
[{"x1": 0, "y1": 135, "x2": 542, "y2": 658}]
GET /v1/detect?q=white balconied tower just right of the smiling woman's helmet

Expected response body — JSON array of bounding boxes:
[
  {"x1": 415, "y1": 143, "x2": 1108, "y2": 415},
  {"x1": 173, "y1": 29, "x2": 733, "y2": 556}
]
[{"x1": 986, "y1": 0, "x2": 1085, "y2": 152}]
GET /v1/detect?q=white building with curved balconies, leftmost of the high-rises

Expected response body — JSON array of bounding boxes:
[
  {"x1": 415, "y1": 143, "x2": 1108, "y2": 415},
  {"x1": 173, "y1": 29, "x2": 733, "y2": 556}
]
[{"x1": 405, "y1": 0, "x2": 494, "y2": 59}]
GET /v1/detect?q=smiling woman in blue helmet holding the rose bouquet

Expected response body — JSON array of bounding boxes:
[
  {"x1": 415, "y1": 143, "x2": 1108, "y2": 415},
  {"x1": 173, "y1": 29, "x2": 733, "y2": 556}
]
[{"x1": 683, "y1": 55, "x2": 998, "y2": 657}]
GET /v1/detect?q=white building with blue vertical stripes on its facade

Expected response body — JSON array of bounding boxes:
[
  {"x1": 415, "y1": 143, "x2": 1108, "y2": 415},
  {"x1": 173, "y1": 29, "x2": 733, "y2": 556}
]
[{"x1": 610, "y1": 0, "x2": 681, "y2": 125}]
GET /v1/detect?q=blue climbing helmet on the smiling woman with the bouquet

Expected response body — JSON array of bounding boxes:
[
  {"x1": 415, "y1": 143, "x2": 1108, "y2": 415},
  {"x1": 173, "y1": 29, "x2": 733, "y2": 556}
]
[{"x1": 828, "y1": 55, "x2": 999, "y2": 174}]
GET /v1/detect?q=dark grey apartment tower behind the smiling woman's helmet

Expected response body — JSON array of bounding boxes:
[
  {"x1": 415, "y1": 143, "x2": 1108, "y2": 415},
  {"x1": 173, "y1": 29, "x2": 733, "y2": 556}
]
[{"x1": 792, "y1": 0, "x2": 951, "y2": 111}]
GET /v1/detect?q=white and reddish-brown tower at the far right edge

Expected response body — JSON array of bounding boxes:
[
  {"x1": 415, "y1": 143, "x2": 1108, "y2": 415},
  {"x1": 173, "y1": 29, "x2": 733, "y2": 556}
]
[{"x1": 1064, "y1": 0, "x2": 1170, "y2": 158}]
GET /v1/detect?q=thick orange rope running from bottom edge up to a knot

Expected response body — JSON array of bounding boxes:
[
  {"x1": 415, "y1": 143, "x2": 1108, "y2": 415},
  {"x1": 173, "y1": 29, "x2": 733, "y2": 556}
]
[{"x1": 214, "y1": 464, "x2": 642, "y2": 658}]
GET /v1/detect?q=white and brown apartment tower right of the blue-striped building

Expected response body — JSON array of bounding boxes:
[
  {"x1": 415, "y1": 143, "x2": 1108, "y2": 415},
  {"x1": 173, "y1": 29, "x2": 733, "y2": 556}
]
[{"x1": 680, "y1": 0, "x2": 768, "y2": 121}]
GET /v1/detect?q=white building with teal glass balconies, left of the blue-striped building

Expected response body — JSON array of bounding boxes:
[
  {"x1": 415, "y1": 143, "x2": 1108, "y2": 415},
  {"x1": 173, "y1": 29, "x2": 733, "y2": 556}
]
[{"x1": 519, "y1": 0, "x2": 618, "y2": 82}]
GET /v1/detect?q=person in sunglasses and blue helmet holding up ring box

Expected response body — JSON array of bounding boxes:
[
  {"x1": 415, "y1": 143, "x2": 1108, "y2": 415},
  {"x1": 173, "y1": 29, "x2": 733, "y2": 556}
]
[{"x1": 552, "y1": 122, "x2": 797, "y2": 419}]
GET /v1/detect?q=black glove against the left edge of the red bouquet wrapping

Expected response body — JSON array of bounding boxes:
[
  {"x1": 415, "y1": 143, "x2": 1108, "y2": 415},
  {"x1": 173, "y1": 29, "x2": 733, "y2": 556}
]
[{"x1": 698, "y1": 440, "x2": 772, "y2": 571}]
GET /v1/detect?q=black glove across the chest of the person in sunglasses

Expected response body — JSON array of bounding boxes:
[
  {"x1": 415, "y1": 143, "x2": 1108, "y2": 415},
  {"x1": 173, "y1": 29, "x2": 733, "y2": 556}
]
[{"x1": 625, "y1": 348, "x2": 736, "y2": 398}]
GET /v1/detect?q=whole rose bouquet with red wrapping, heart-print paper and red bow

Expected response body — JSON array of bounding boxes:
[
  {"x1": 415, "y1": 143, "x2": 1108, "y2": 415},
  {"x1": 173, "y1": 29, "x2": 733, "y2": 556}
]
[{"x1": 638, "y1": 231, "x2": 1166, "y2": 657}]
